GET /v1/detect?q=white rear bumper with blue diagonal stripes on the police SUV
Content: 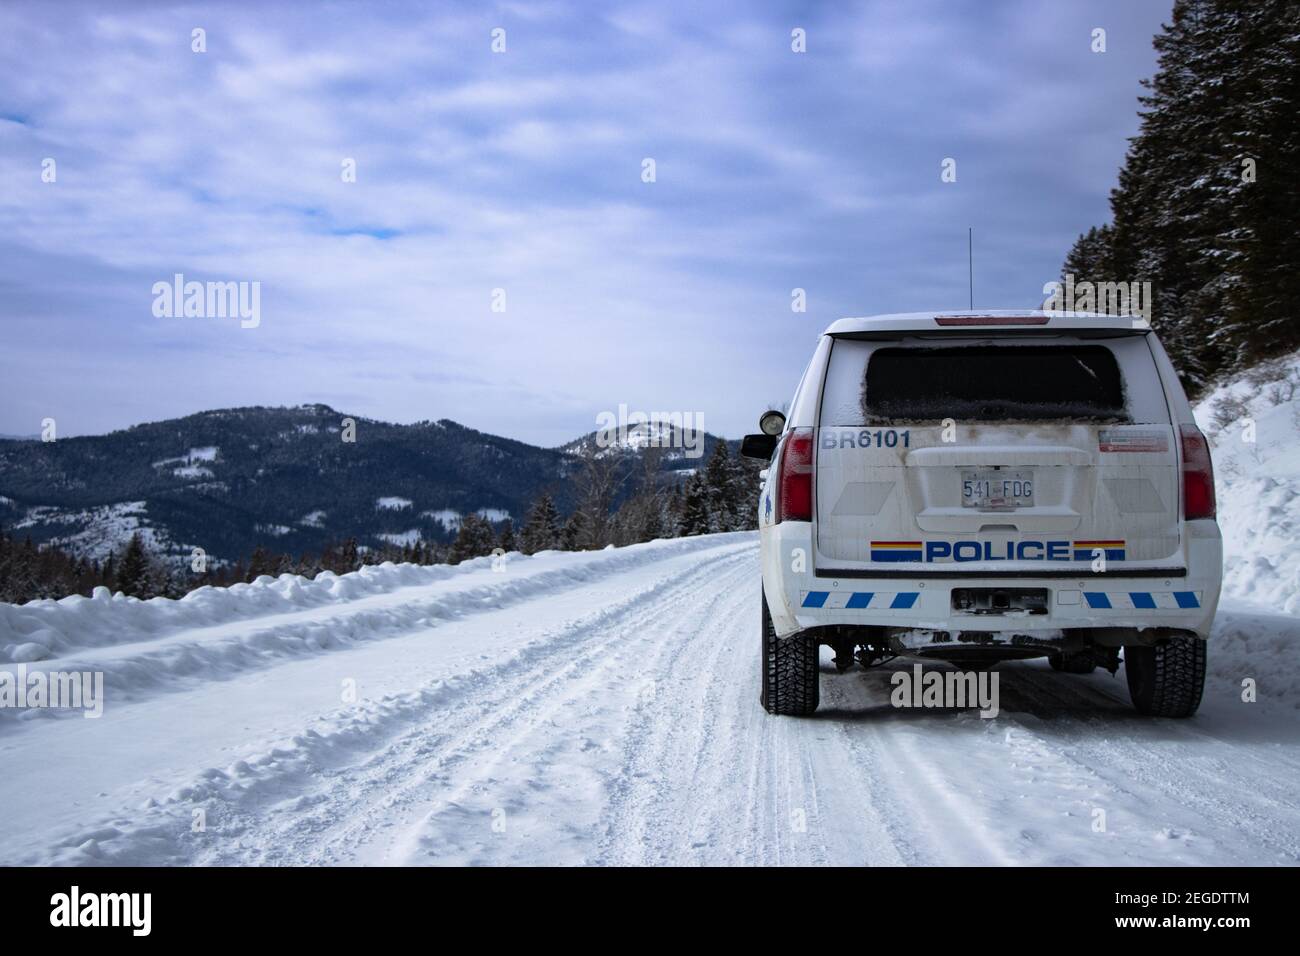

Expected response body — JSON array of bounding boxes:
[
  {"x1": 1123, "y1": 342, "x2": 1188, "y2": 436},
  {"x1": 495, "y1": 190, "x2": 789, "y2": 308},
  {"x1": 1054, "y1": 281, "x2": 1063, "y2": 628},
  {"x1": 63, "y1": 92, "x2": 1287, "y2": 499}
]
[{"x1": 763, "y1": 522, "x2": 1223, "y2": 637}]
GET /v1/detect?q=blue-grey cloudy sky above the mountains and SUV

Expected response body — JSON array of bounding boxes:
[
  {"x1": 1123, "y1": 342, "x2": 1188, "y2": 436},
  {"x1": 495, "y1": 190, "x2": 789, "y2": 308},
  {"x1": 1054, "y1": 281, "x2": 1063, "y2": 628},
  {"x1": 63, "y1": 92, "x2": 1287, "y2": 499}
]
[{"x1": 0, "y1": 0, "x2": 1170, "y2": 445}]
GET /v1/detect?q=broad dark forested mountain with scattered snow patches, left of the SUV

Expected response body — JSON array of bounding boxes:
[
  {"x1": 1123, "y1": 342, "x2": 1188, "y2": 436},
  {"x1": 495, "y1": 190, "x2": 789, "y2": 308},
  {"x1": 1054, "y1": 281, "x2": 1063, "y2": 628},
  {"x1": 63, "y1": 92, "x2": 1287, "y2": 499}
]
[{"x1": 0, "y1": 405, "x2": 668, "y2": 562}]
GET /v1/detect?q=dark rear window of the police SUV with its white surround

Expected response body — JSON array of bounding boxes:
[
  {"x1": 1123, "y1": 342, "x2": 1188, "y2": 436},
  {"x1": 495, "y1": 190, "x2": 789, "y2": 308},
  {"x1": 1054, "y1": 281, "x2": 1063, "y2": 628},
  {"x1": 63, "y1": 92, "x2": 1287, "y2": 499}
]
[{"x1": 822, "y1": 337, "x2": 1169, "y2": 425}]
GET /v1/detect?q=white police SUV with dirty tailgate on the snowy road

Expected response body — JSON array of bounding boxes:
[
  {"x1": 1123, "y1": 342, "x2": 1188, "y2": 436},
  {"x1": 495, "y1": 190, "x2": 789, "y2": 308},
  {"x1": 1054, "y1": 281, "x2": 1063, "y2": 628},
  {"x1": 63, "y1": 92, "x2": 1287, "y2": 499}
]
[{"x1": 742, "y1": 312, "x2": 1222, "y2": 717}]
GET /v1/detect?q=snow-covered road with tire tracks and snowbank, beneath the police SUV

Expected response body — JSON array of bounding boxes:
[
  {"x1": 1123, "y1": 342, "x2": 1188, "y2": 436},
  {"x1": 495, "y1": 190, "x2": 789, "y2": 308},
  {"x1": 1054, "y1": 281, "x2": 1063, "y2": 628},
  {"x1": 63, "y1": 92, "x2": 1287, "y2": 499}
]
[{"x1": 0, "y1": 535, "x2": 1300, "y2": 865}]
